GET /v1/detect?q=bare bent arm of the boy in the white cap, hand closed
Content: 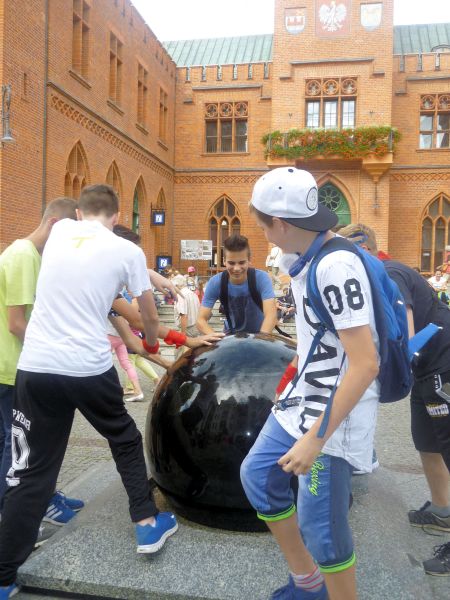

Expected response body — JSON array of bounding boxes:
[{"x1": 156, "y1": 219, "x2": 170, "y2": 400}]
[{"x1": 278, "y1": 325, "x2": 378, "y2": 475}]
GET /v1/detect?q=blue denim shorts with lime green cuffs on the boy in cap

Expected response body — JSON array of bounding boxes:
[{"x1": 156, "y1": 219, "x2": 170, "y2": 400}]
[{"x1": 241, "y1": 414, "x2": 355, "y2": 573}]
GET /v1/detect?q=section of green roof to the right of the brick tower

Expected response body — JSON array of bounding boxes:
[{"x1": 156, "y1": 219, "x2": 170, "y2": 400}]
[{"x1": 394, "y1": 22, "x2": 450, "y2": 54}]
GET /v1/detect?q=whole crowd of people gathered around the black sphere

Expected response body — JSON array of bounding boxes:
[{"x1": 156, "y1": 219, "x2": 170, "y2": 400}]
[{"x1": 0, "y1": 167, "x2": 450, "y2": 600}]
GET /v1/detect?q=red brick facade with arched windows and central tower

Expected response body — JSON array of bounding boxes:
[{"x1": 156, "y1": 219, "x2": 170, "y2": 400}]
[{"x1": 0, "y1": 0, "x2": 450, "y2": 272}]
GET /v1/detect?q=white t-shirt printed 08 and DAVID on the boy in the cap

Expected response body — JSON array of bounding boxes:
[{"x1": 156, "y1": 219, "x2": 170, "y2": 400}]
[{"x1": 274, "y1": 250, "x2": 379, "y2": 472}]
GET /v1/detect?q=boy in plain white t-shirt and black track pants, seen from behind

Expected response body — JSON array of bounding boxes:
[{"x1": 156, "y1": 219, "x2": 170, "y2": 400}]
[{"x1": 0, "y1": 185, "x2": 221, "y2": 598}]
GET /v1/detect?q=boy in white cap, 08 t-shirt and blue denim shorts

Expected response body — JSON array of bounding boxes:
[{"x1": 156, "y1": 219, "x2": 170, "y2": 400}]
[{"x1": 241, "y1": 167, "x2": 379, "y2": 600}]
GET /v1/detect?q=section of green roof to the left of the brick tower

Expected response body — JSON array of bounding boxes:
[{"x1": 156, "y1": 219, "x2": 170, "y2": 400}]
[{"x1": 163, "y1": 33, "x2": 273, "y2": 67}]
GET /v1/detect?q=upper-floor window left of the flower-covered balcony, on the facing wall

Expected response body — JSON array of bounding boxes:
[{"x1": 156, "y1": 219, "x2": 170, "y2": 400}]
[{"x1": 205, "y1": 102, "x2": 248, "y2": 153}]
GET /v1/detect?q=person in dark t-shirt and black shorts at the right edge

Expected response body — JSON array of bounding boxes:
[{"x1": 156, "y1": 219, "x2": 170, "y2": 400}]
[{"x1": 339, "y1": 223, "x2": 450, "y2": 576}]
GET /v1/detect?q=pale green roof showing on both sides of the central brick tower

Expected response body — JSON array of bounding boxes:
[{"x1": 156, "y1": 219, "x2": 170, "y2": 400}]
[{"x1": 163, "y1": 23, "x2": 450, "y2": 67}]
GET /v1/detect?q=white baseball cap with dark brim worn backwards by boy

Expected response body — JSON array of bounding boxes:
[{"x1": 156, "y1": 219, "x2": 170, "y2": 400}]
[{"x1": 251, "y1": 167, "x2": 338, "y2": 231}]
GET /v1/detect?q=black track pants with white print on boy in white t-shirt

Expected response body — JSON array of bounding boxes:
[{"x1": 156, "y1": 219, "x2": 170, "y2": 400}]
[{"x1": 0, "y1": 368, "x2": 158, "y2": 586}]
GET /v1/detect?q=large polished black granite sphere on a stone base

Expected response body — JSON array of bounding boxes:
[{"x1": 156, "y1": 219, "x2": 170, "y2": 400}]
[{"x1": 146, "y1": 333, "x2": 296, "y2": 528}]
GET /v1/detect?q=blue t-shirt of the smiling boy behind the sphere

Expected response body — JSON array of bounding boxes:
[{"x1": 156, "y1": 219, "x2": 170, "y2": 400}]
[{"x1": 202, "y1": 269, "x2": 275, "y2": 333}]
